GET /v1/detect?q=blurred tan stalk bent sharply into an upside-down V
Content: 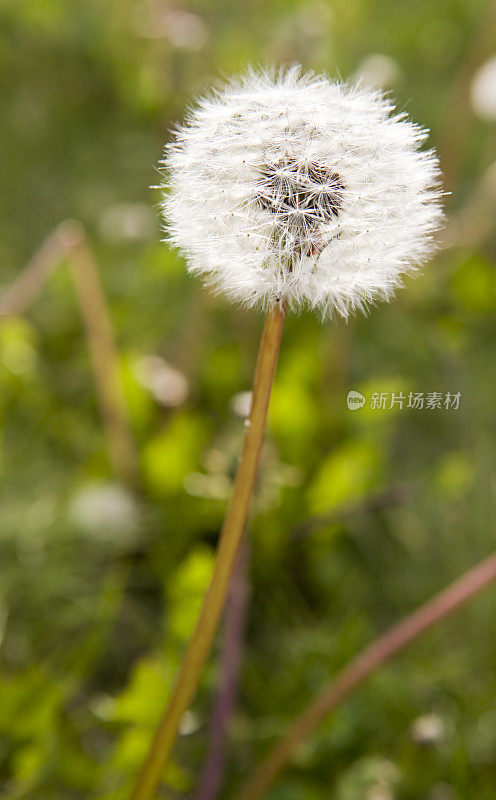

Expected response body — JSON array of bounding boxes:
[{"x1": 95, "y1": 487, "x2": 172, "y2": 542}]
[{"x1": 0, "y1": 220, "x2": 138, "y2": 487}]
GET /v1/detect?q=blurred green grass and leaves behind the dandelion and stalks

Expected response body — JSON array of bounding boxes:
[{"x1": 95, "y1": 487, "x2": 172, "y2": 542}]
[{"x1": 0, "y1": 0, "x2": 496, "y2": 800}]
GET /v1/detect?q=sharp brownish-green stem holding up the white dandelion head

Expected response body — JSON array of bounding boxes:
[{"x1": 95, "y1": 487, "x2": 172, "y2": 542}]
[{"x1": 131, "y1": 301, "x2": 285, "y2": 800}]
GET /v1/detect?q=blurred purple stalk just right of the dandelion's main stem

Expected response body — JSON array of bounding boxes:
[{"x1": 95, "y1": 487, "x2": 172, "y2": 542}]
[{"x1": 191, "y1": 536, "x2": 249, "y2": 800}]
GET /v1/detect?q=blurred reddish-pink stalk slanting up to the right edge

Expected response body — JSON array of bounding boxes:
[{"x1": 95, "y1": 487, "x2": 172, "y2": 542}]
[{"x1": 237, "y1": 553, "x2": 496, "y2": 800}]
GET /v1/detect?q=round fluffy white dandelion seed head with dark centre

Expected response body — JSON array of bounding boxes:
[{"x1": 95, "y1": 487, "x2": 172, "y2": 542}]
[{"x1": 163, "y1": 66, "x2": 442, "y2": 317}]
